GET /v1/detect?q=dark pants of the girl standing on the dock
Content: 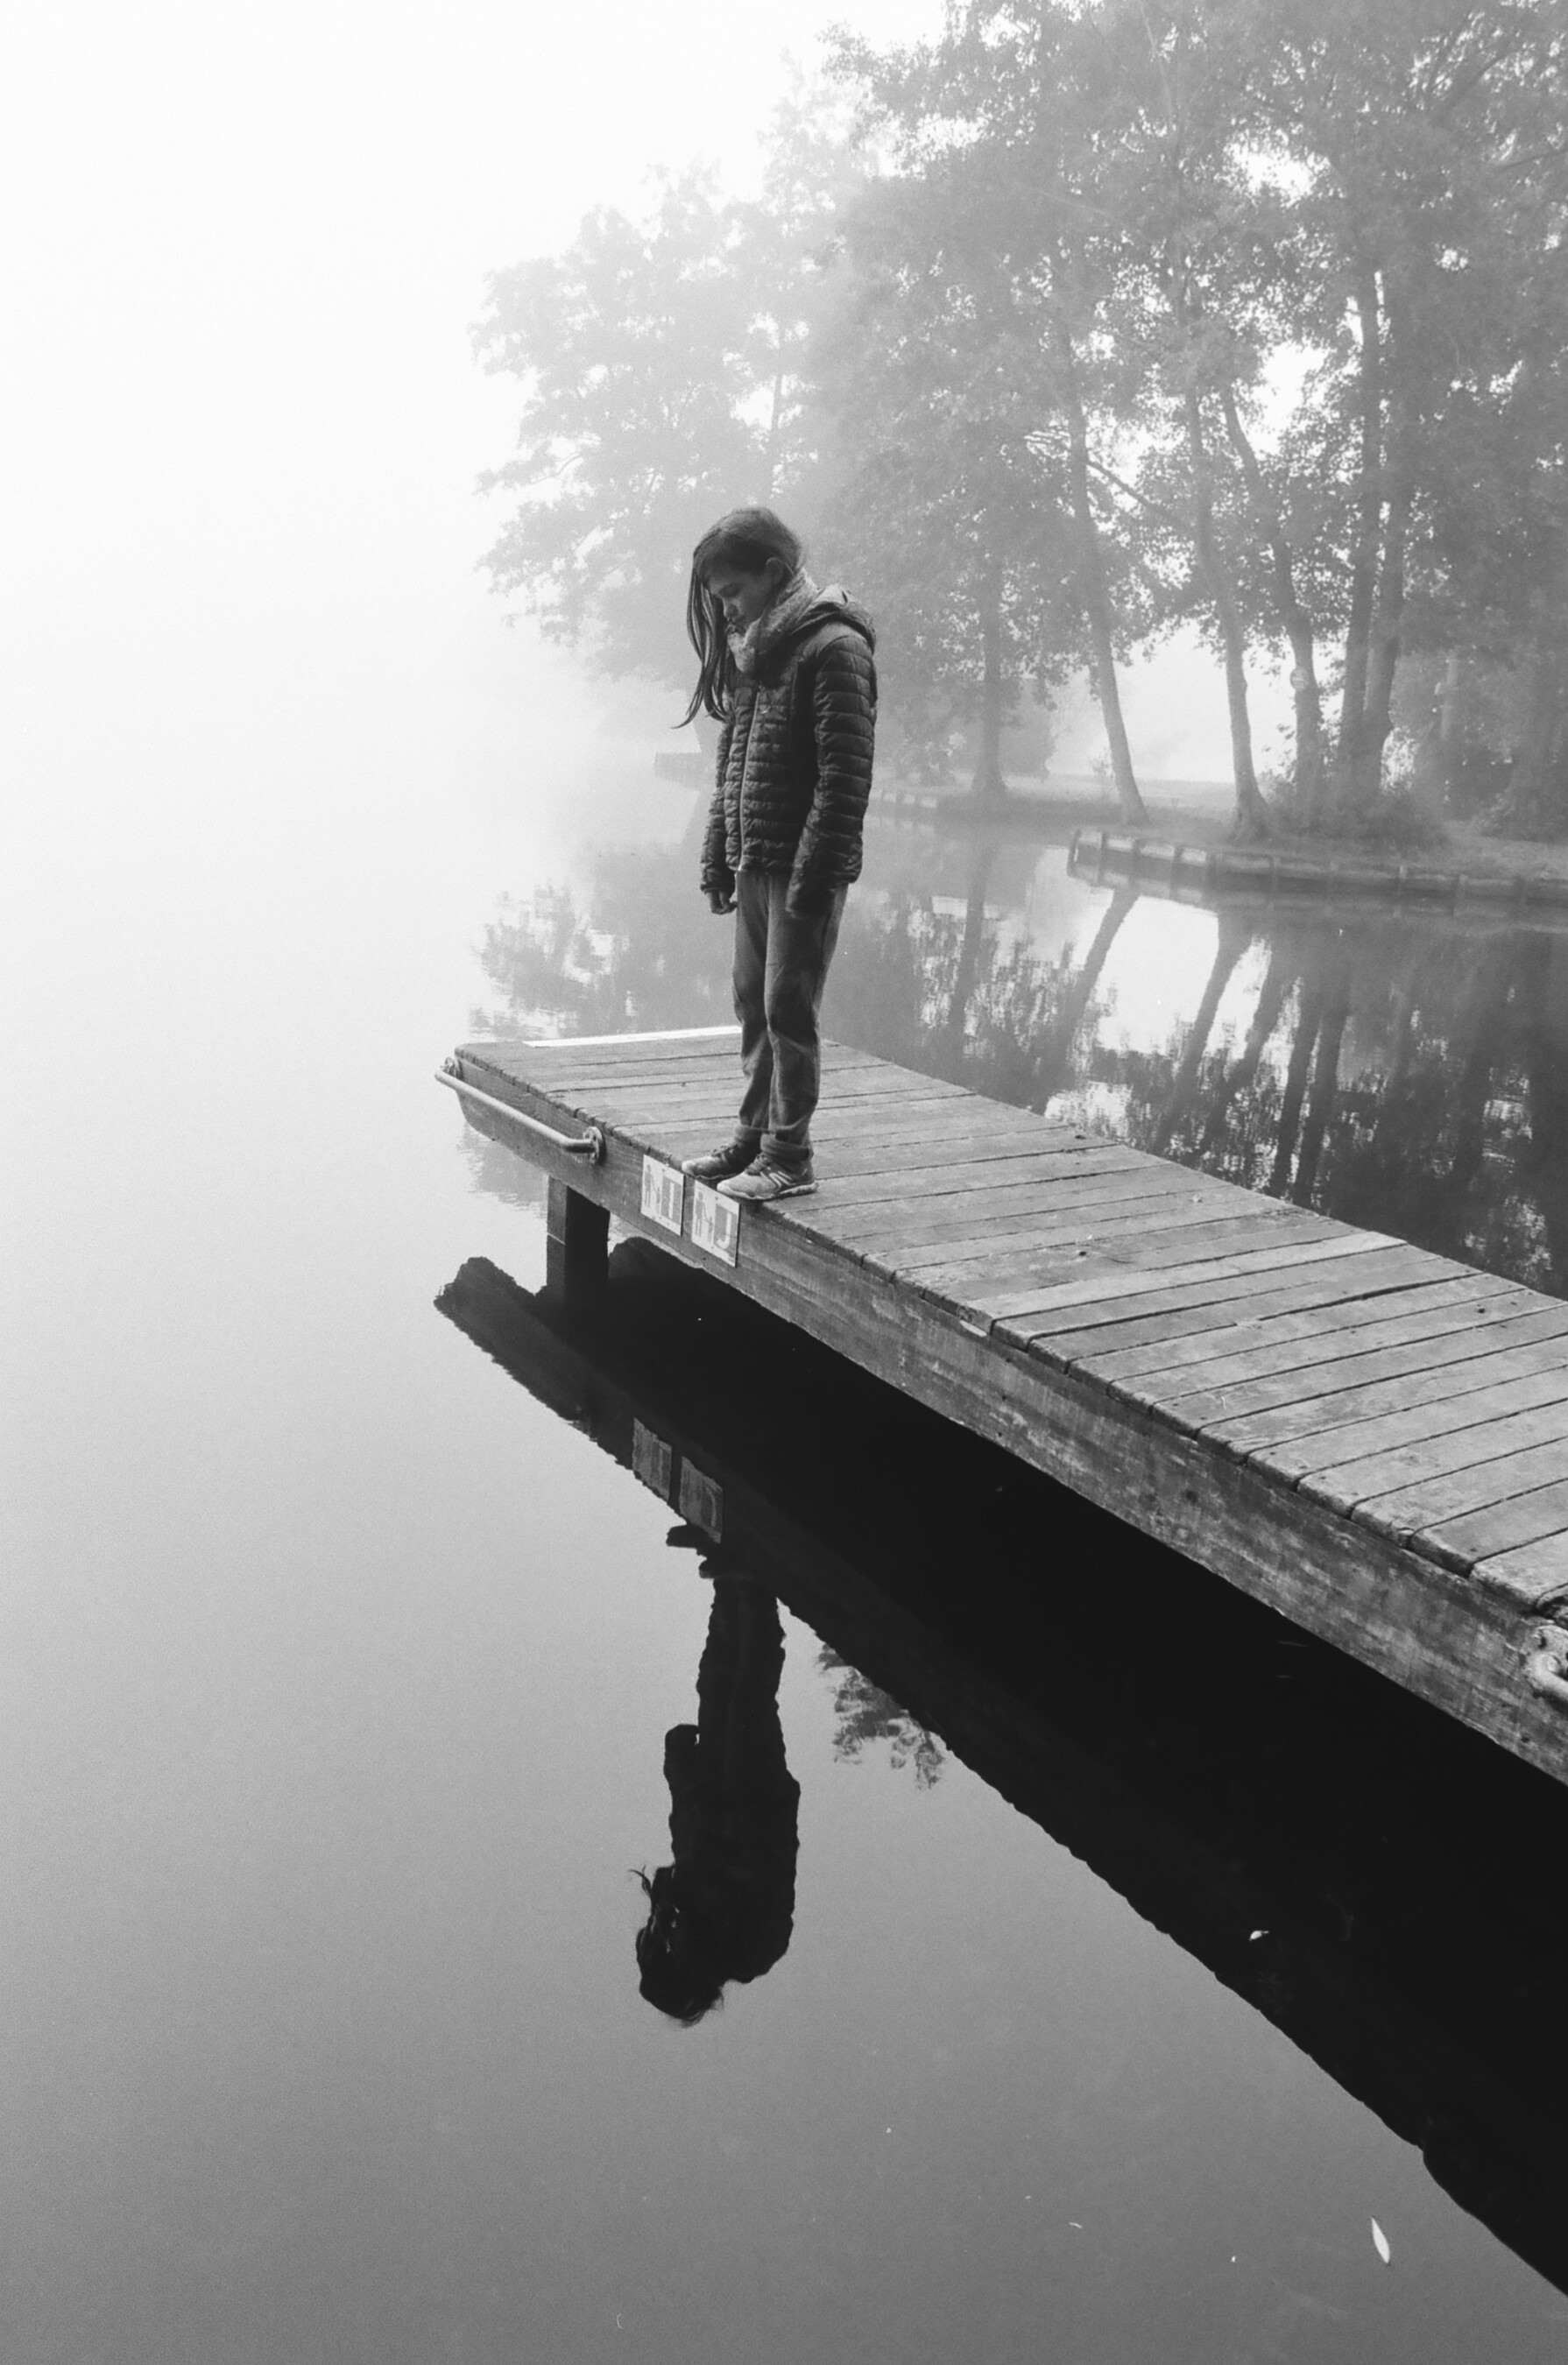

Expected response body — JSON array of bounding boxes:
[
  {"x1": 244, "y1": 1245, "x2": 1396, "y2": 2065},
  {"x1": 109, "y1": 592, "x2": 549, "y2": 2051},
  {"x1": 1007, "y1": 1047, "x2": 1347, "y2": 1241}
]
[{"x1": 736, "y1": 871, "x2": 847, "y2": 1166}]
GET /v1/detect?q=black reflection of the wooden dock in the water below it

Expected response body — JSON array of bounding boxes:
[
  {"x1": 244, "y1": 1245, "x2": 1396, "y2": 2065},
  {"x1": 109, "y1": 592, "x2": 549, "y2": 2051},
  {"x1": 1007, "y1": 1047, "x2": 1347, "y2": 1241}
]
[{"x1": 440, "y1": 1244, "x2": 1568, "y2": 2287}]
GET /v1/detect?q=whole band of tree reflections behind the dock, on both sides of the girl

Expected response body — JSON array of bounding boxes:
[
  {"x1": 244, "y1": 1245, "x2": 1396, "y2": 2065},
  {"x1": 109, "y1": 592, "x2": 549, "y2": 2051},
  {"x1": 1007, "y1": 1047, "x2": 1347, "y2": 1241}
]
[{"x1": 477, "y1": 807, "x2": 1568, "y2": 1294}]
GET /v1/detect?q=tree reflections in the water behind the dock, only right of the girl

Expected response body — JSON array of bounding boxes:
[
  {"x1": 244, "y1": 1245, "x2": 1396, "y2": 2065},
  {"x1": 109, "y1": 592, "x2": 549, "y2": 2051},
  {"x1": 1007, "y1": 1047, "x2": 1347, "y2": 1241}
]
[{"x1": 844, "y1": 858, "x2": 1568, "y2": 1294}]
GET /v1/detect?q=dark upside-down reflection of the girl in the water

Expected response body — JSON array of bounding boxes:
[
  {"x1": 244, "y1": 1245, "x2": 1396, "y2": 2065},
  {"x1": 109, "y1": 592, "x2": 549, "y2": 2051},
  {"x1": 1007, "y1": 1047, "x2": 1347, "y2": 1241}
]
[{"x1": 636, "y1": 1575, "x2": 800, "y2": 2027}]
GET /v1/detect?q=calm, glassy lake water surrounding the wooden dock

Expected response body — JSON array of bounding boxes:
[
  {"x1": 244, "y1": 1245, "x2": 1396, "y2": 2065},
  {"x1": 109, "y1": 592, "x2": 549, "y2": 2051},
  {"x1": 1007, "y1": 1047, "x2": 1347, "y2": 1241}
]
[{"x1": 0, "y1": 754, "x2": 1568, "y2": 2365}]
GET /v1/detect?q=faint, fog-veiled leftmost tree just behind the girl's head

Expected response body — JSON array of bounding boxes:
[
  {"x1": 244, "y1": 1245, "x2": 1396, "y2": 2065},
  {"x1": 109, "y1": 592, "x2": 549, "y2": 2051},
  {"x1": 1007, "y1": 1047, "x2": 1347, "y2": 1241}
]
[{"x1": 476, "y1": 92, "x2": 856, "y2": 683}]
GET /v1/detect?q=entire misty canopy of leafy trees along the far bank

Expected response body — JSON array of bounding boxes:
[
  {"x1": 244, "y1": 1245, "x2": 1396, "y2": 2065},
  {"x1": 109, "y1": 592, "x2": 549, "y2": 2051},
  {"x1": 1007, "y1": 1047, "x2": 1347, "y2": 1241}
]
[{"x1": 480, "y1": 0, "x2": 1568, "y2": 835}]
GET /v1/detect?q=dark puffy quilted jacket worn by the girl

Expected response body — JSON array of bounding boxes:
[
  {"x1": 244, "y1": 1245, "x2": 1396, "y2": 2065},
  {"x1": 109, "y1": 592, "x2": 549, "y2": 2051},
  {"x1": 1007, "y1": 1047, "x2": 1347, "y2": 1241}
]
[{"x1": 703, "y1": 591, "x2": 878, "y2": 906}]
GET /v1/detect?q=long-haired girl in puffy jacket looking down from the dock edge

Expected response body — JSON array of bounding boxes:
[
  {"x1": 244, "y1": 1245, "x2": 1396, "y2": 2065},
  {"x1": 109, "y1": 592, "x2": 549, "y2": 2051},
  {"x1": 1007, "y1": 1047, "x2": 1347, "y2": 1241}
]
[{"x1": 686, "y1": 509, "x2": 878, "y2": 1199}]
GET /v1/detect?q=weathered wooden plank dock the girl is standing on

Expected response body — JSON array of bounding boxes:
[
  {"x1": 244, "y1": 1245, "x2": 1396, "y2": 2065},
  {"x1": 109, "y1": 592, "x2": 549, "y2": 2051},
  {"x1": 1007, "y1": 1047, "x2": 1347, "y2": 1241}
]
[{"x1": 445, "y1": 1029, "x2": 1568, "y2": 1781}]
